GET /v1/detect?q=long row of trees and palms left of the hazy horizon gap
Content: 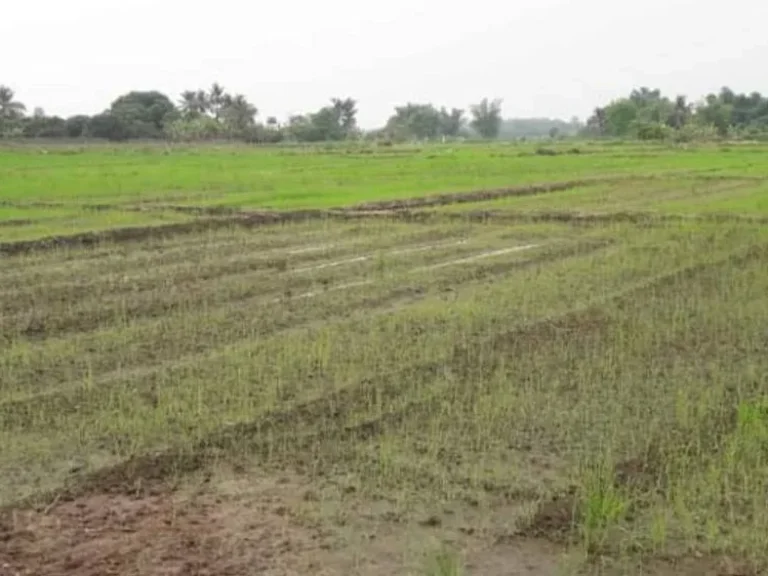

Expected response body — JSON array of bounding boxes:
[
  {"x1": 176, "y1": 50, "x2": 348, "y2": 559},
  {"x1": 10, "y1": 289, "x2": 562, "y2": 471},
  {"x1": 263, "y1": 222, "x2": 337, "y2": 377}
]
[{"x1": 0, "y1": 83, "x2": 502, "y2": 143}]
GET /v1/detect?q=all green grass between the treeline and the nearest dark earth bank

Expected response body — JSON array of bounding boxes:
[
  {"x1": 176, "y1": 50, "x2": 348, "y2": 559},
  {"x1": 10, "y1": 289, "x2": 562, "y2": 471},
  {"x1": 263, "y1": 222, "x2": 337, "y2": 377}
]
[{"x1": 0, "y1": 144, "x2": 768, "y2": 242}]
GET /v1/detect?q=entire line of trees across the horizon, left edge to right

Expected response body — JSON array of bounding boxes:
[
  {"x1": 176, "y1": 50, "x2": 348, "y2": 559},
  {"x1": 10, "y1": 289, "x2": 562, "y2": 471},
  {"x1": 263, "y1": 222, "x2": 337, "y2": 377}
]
[{"x1": 0, "y1": 83, "x2": 768, "y2": 143}]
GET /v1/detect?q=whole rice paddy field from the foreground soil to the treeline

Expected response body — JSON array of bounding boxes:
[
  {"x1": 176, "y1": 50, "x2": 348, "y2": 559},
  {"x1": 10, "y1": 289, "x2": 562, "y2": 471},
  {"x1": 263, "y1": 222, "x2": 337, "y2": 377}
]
[{"x1": 0, "y1": 143, "x2": 768, "y2": 576}]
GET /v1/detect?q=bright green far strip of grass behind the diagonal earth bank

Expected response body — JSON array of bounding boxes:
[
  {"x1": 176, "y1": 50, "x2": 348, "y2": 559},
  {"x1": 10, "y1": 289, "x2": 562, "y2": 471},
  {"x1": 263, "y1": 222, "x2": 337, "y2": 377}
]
[{"x1": 0, "y1": 145, "x2": 768, "y2": 209}]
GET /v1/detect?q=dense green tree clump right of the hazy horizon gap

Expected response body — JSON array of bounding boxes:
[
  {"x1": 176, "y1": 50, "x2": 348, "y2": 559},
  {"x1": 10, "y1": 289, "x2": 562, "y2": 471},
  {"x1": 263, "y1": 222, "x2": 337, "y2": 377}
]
[{"x1": 581, "y1": 87, "x2": 768, "y2": 141}]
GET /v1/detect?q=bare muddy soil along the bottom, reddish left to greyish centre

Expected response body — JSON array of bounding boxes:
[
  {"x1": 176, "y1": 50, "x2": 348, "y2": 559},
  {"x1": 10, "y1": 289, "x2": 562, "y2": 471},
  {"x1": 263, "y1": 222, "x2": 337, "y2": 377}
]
[{"x1": 0, "y1": 477, "x2": 559, "y2": 576}]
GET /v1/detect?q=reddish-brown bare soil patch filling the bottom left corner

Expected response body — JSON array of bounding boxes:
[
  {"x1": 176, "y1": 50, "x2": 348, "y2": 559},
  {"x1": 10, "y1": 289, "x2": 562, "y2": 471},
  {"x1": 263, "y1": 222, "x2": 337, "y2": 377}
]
[{"x1": 0, "y1": 476, "x2": 331, "y2": 576}]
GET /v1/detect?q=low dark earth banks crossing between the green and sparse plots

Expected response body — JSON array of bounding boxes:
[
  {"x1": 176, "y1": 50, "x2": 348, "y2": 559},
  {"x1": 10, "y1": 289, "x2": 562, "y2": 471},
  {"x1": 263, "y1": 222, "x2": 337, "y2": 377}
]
[{"x1": 0, "y1": 171, "x2": 768, "y2": 256}]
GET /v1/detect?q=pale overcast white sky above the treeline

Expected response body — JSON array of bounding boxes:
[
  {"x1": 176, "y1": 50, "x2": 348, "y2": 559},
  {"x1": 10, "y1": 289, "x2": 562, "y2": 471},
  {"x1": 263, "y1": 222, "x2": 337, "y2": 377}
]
[{"x1": 0, "y1": 0, "x2": 768, "y2": 128}]
